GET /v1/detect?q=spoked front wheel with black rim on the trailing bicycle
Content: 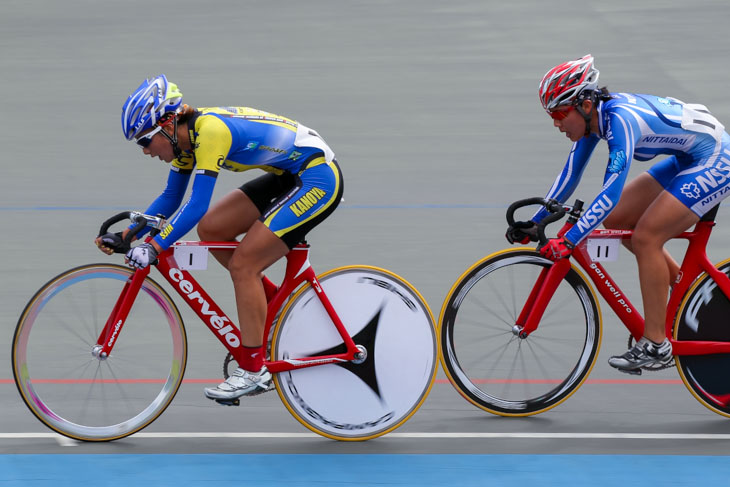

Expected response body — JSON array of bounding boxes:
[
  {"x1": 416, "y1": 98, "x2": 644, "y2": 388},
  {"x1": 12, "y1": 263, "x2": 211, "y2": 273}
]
[{"x1": 439, "y1": 252, "x2": 602, "y2": 416}]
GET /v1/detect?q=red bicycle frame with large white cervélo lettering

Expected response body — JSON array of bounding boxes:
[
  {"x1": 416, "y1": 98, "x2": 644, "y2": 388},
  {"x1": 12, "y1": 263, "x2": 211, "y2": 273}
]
[{"x1": 97, "y1": 242, "x2": 360, "y2": 373}]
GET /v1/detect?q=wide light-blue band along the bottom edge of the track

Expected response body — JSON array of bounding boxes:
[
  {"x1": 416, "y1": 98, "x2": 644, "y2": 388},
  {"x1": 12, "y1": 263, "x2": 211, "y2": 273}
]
[{"x1": 0, "y1": 454, "x2": 730, "y2": 487}]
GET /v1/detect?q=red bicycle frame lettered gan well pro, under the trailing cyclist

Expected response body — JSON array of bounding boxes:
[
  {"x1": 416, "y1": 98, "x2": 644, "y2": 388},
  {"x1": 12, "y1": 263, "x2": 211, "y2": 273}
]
[{"x1": 516, "y1": 219, "x2": 730, "y2": 355}]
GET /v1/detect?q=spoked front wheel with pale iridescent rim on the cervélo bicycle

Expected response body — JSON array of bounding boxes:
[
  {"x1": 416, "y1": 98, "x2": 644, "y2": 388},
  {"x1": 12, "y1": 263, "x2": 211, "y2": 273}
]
[{"x1": 12, "y1": 264, "x2": 187, "y2": 441}]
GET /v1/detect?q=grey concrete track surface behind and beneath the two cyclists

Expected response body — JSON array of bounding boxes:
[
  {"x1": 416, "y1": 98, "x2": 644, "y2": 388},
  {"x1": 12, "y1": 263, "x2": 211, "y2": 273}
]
[{"x1": 0, "y1": 0, "x2": 730, "y2": 454}]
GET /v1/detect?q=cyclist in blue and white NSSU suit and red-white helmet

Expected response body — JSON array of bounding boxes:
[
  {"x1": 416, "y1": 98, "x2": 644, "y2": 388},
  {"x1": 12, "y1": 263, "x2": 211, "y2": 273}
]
[{"x1": 507, "y1": 55, "x2": 730, "y2": 373}]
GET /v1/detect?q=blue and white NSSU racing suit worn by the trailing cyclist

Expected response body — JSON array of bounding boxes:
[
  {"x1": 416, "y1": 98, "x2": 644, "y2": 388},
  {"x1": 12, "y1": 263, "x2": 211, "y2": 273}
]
[{"x1": 533, "y1": 93, "x2": 730, "y2": 244}]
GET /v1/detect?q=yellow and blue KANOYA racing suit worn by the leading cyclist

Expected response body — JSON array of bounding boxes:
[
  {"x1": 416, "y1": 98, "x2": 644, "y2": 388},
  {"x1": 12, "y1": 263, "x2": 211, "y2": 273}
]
[{"x1": 139, "y1": 107, "x2": 342, "y2": 249}]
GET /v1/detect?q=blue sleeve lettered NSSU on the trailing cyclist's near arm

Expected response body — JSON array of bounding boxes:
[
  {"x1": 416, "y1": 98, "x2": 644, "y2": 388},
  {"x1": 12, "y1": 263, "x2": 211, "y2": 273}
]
[{"x1": 565, "y1": 110, "x2": 641, "y2": 244}]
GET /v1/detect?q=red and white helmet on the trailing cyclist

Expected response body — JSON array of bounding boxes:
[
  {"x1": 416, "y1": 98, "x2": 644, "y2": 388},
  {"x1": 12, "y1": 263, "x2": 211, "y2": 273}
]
[{"x1": 539, "y1": 54, "x2": 598, "y2": 111}]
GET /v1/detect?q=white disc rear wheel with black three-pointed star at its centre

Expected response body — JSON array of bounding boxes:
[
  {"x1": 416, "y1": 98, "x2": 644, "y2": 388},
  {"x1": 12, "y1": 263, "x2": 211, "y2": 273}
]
[{"x1": 272, "y1": 266, "x2": 438, "y2": 441}]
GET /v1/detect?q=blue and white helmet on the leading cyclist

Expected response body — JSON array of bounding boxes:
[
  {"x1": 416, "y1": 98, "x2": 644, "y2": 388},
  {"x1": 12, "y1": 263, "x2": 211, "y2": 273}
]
[{"x1": 122, "y1": 74, "x2": 182, "y2": 140}]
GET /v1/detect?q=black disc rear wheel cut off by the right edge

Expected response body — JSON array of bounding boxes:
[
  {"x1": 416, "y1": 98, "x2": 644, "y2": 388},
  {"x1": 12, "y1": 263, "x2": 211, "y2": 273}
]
[{"x1": 673, "y1": 259, "x2": 730, "y2": 417}]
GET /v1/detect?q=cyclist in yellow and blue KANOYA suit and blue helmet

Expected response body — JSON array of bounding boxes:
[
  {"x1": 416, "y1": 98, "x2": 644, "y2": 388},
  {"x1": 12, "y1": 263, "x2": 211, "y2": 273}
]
[{"x1": 96, "y1": 75, "x2": 343, "y2": 400}]
